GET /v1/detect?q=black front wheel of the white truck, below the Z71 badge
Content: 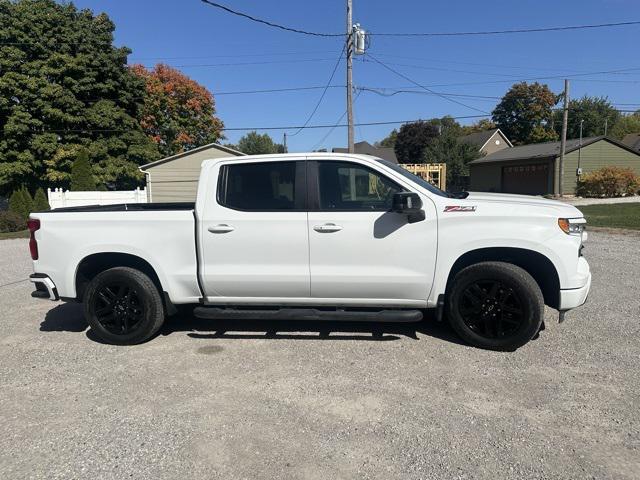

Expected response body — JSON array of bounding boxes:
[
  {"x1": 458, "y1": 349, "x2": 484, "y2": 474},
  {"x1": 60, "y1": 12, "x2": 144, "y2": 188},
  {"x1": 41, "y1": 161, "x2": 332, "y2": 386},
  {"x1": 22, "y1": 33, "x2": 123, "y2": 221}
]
[{"x1": 446, "y1": 262, "x2": 544, "y2": 351}]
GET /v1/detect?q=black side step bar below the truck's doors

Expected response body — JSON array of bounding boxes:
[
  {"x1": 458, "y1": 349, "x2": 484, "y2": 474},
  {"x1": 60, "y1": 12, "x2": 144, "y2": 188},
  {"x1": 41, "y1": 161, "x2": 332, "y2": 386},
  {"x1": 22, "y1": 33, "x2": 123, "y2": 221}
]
[{"x1": 193, "y1": 307, "x2": 422, "y2": 323}]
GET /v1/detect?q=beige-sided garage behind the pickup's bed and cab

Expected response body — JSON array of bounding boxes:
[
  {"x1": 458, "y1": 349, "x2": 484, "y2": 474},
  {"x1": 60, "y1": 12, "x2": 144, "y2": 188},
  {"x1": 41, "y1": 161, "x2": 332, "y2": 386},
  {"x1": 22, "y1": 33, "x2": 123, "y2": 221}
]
[{"x1": 140, "y1": 143, "x2": 244, "y2": 203}]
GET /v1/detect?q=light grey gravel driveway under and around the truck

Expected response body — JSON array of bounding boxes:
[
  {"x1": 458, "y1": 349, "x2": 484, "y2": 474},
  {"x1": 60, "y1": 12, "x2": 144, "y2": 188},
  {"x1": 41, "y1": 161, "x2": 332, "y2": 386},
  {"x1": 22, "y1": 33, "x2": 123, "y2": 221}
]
[{"x1": 0, "y1": 232, "x2": 640, "y2": 480}]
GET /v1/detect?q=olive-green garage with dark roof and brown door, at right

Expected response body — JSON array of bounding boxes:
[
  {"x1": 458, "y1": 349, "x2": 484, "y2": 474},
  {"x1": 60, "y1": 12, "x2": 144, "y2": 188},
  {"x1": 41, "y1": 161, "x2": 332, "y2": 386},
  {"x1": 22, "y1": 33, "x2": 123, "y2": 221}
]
[{"x1": 469, "y1": 136, "x2": 640, "y2": 195}]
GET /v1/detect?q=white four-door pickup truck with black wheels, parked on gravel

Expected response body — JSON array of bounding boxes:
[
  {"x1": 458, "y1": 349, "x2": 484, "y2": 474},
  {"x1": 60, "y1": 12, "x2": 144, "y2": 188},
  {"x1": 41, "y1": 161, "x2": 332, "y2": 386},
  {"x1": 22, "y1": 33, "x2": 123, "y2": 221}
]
[{"x1": 29, "y1": 153, "x2": 591, "y2": 350}]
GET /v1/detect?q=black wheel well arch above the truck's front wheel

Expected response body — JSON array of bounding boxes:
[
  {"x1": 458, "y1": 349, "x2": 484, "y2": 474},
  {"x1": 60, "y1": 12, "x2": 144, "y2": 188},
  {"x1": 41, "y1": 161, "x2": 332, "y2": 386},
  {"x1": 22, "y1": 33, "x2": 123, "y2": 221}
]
[{"x1": 447, "y1": 247, "x2": 560, "y2": 308}]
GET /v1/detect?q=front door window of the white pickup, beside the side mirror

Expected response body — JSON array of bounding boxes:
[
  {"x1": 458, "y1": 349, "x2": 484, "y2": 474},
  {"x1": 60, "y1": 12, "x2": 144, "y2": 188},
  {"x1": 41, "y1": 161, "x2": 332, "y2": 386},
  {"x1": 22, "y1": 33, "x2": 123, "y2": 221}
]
[{"x1": 318, "y1": 161, "x2": 403, "y2": 211}]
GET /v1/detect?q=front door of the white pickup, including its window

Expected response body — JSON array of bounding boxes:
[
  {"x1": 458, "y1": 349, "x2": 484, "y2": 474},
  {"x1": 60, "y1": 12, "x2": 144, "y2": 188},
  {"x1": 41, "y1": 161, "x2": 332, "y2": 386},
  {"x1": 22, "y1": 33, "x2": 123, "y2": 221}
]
[{"x1": 308, "y1": 160, "x2": 437, "y2": 306}]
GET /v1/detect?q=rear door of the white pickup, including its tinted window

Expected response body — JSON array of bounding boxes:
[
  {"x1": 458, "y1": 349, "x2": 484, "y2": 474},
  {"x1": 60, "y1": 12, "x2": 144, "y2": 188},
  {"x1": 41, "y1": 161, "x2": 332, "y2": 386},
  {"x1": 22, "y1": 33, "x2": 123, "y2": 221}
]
[{"x1": 199, "y1": 157, "x2": 309, "y2": 303}]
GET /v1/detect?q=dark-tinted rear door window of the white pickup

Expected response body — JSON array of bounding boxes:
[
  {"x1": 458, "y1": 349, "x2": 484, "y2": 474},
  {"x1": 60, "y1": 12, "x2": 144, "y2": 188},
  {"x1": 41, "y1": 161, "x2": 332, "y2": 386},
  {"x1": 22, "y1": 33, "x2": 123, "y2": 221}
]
[{"x1": 218, "y1": 162, "x2": 296, "y2": 211}]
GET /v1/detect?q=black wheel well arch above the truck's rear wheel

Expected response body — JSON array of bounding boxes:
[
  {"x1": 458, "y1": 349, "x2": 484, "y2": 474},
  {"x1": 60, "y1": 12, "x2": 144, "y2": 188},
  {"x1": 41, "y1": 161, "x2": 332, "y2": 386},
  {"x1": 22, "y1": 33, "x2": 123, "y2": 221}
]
[{"x1": 76, "y1": 252, "x2": 162, "y2": 302}]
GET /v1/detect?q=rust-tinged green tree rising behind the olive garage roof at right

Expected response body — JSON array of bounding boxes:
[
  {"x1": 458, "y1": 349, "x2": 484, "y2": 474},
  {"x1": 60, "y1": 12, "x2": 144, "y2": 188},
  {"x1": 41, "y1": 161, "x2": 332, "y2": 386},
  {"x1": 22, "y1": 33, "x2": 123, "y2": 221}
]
[{"x1": 492, "y1": 82, "x2": 558, "y2": 145}]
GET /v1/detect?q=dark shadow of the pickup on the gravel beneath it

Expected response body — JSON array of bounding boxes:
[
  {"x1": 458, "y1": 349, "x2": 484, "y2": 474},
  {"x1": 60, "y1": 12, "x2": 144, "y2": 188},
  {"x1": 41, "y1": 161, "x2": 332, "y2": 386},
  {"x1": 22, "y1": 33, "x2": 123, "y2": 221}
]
[{"x1": 40, "y1": 303, "x2": 465, "y2": 345}]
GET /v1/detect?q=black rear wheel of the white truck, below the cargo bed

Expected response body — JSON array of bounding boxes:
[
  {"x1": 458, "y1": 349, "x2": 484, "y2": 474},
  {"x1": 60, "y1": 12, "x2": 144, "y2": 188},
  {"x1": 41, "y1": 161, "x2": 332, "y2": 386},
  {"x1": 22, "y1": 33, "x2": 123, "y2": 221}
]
[{"x1": 84, "y1": 267, "x2": 165, "y2": 345}]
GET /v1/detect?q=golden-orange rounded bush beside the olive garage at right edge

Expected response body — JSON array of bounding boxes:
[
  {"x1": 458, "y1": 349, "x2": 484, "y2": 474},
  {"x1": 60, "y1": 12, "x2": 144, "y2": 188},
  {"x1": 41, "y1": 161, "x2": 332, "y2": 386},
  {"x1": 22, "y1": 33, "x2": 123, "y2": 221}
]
[{"x1": 576, "y1": 167, "x2": 640, "y2": 198}]
